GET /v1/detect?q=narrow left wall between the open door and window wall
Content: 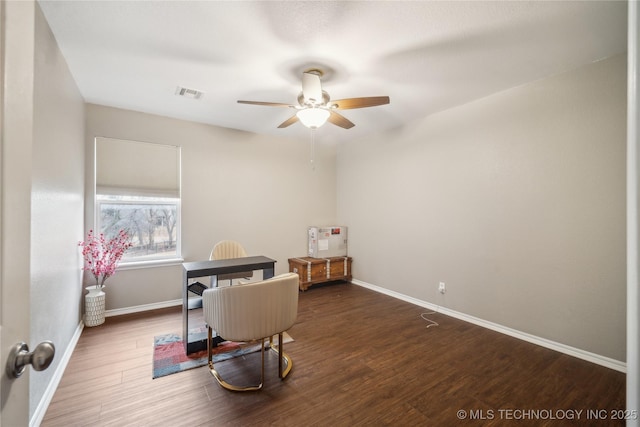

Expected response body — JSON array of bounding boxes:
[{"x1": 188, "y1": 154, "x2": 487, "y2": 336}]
[{"x1": 30, "y1": 0, "x2": 85, "y2": 414}]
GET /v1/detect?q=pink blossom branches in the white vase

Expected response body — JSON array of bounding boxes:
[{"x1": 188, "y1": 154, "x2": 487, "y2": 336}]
[{"x1": 78, "y1": 230, "x2": 132, "y2": 289}]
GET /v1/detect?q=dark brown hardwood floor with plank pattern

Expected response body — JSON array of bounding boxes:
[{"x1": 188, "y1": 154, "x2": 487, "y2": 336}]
[{"x1": 42, "y1": 283, "x2": 625, "y2": 427}]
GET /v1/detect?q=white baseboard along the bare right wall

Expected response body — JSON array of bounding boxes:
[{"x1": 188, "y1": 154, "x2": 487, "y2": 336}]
[{"x1": 351, "y1": 279, "x2": 627, "y2": 374}]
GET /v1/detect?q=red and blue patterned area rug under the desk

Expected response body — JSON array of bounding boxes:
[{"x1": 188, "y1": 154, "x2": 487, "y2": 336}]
[{"x1": 153, "y1": 332, "x2": 293, "y2": 378}]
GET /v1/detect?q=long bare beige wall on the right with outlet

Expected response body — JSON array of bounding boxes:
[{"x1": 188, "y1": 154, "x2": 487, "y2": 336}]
[{"x1": 337, "y1": 52, "x2": 626, "y2": 361}]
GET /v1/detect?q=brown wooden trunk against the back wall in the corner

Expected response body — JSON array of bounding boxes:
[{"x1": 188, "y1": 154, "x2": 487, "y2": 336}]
[{"x1": 289, "y1": 257, "x2": 351, "y2": 291}]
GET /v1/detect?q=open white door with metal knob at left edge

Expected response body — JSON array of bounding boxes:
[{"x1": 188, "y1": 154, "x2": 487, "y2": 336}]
[{"x1": 0, "y1": 1, "x2": 35, "y2": 427}]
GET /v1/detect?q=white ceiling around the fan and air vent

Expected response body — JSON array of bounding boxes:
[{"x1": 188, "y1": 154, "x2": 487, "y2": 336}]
[{"x1": 39, "y1": 0, "x2": 627, "y2": 142}]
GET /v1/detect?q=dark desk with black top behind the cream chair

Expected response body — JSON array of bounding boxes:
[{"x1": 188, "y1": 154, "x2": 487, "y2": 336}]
[{"x1": 182, "y1": 256, "x2": 276, "y2": 354}]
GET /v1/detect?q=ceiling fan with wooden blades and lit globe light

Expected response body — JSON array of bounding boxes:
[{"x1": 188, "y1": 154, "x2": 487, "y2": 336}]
[{"x1": 238, "y1": 69, "x2": 389, "y2": 129}]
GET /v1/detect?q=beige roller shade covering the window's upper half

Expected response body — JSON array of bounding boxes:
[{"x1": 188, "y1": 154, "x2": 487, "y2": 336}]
[{"x1": 96, "y1": 137, "x2": 180, "y2": 198}]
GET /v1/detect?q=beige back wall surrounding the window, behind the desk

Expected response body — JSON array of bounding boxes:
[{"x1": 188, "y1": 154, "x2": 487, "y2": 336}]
[{"x1": 85, "y1": 105, "x2": 336, "y2": 310}]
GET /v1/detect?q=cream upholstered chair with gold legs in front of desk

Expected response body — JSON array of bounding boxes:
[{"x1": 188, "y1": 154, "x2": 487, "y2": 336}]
[{"x1": 202, "y1": 273, "x2": 299, "y2": 391}]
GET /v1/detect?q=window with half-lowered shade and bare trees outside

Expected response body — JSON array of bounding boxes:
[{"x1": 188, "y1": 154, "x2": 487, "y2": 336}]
[{"x1": 95, "y1": 138, "x2": 181, "y2": 264}]
